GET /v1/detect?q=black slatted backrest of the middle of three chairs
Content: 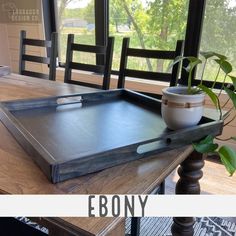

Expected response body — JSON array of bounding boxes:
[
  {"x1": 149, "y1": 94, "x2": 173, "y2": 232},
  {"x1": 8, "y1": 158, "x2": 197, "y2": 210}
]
[{"x1": 64, "y1": 34, "x2": 114, "y2": 89}]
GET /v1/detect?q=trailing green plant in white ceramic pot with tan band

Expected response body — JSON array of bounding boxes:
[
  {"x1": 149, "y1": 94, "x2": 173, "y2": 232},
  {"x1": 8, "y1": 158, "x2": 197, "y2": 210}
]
[{"x1": 162, "y1": 52, "x2": 236, "y2": 175}]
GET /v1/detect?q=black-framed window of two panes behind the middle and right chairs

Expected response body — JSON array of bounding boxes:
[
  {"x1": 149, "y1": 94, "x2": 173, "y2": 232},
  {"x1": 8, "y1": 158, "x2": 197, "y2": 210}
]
[{"x1": 47, "y1": 0, "x2": 206, "y2": 84}]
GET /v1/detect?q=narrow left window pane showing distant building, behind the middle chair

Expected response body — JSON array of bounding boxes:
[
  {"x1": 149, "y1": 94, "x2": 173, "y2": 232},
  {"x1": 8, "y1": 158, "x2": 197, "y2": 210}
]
[{"x1": 56, "y1": 0, "x2": 95, "y2": 63}]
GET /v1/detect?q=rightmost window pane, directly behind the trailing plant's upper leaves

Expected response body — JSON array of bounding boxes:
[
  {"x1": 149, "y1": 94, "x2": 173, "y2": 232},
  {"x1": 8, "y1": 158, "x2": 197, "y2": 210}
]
[{"x1": 197, "y1": 0, "x2": 236, "y2": 82}]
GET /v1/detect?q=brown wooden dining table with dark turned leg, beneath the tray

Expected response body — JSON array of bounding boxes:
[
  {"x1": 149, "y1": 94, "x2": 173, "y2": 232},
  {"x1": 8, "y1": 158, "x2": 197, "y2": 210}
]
[{"x1": 0, "y1": 74, "x2": 203, "y2": 236}]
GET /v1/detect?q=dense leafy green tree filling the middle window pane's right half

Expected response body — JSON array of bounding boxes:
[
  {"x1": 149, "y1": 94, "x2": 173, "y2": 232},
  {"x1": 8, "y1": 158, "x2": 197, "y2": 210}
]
[{"x1": 147, "y1": 0, "x2": 188, "y2": 71}]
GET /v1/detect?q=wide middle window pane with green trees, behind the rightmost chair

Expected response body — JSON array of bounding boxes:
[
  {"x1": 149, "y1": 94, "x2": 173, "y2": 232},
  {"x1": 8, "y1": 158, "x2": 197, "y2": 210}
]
[{"x1": 109, "y1": 0, "x2": 189, "y2": 71}]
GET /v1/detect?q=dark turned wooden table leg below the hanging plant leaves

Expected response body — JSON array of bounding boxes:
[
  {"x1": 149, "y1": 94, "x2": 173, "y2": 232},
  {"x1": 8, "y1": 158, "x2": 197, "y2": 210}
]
[{"x1": 171, "y1": 151, "x2": 204, "y2": 236}]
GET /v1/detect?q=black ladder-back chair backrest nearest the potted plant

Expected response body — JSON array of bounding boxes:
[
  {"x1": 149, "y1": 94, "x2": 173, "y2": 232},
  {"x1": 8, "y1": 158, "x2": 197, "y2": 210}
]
[{"x1": 118, "y1": 38, "x2": 183, "y2": 95}]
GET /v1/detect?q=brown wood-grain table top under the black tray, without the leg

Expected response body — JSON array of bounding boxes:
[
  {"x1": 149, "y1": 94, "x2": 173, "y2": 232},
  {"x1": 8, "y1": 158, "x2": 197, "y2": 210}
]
[{"x1": 0, "y1": 74, "x2": 192, "y2": 235}]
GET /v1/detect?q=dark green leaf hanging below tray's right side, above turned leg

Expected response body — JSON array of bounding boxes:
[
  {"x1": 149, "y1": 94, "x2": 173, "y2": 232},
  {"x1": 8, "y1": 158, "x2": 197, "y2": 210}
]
[{"x1": 193, "y1": 135, "x2": 218, "y2": 153}]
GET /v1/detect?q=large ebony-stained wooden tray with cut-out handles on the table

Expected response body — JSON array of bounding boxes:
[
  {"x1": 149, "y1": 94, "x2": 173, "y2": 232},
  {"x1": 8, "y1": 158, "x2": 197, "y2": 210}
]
[{"x1": 0, "y1": 89, "x2": 222, "y2": 183}]
